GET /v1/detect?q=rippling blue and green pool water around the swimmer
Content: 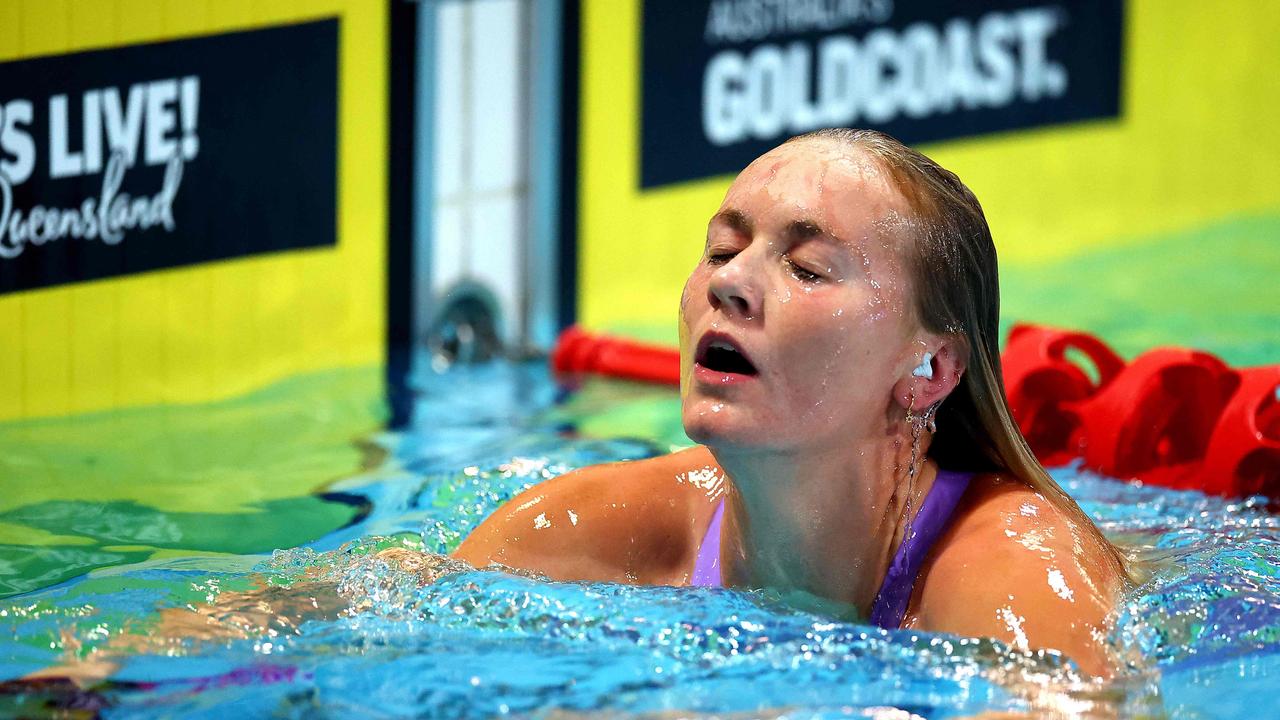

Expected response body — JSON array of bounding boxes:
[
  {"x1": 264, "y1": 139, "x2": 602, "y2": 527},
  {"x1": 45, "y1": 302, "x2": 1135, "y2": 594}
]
[{"x1": 0, "y1": 363, "x2": 1280, "y2": 719}]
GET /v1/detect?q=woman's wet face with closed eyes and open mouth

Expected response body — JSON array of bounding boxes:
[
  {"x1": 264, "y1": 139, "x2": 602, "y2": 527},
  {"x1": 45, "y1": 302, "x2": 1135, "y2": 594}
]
[{"x1": 680, "y1": 140, "x2": 920, "y2": 448}]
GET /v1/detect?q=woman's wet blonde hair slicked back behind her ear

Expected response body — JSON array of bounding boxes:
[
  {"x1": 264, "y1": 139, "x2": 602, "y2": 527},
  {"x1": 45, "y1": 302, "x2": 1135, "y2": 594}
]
[{"x1": 787, "y1": 128, "x2": 1092, "y2": 532}]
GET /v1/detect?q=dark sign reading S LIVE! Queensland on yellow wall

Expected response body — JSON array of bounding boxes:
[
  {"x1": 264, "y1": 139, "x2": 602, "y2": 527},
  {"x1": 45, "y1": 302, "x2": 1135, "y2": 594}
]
[{"x1": 0, "y1": 19, "x2": 339, "y2": 293}]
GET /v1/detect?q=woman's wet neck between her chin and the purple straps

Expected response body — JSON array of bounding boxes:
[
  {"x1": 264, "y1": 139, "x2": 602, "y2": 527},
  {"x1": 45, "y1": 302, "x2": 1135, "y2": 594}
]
[{"x1": 712, "y1": 423, "x2": 936, "y2": 616}]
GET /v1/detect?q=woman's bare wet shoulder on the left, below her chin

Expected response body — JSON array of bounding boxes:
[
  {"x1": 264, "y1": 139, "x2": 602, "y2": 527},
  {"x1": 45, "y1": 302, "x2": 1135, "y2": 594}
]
[{"x1": 454, "y1": 447, "x2": 724, "y2": 583}]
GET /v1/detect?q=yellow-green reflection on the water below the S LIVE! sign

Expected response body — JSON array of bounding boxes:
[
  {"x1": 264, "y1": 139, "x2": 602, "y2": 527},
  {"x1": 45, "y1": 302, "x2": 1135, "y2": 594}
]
[{"x1": 0, "y1": 369, "x2": 383, "y2": 598}]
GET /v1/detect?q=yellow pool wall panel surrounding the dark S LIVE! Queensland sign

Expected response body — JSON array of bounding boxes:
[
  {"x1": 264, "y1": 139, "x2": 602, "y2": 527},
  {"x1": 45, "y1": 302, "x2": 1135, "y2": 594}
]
[{"x1": 0, "y1": 0, "x2": 388, "y2": 419}]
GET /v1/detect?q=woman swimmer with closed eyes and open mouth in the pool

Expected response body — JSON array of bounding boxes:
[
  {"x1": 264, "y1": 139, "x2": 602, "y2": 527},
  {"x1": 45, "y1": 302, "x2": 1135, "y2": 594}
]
[{"x1": 456, "y1": 129, "x2": 1126, "y2": 674}]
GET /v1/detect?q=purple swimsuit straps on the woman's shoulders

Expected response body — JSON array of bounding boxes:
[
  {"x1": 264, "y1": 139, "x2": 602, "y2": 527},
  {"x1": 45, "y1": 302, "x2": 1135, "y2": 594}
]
[{"x1": 689, "y1": 470, "x2": 973, "y2": 629}]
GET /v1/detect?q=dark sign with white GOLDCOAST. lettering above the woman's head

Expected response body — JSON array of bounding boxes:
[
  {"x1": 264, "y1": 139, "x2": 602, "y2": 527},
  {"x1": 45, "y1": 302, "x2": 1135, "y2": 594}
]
[{"x1": 640, "y1": 0, "x2": 1124, "y2": 187}]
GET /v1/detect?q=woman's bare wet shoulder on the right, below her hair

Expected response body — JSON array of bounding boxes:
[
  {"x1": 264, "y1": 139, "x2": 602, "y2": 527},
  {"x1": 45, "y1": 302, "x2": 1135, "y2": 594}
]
[{"x1": 909, "y1": 475, "x2": 1124, "y2": 674}]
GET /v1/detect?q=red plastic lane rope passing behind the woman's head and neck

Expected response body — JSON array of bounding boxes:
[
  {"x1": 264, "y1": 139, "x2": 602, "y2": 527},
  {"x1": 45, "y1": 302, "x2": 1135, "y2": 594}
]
[{"x1": 552, "y1": 325, "x2": 1280, "y2": 500}]
